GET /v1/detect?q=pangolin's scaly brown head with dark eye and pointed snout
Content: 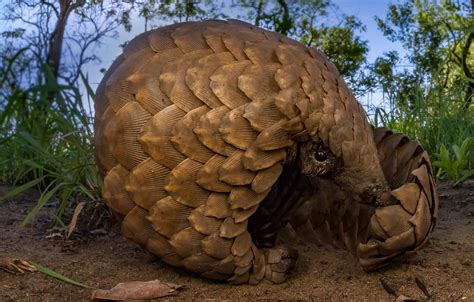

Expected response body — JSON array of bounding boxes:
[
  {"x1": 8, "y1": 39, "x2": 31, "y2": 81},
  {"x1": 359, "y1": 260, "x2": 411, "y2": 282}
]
[{"x1": 296, "y1": 53, "x2": 391, "y2": 205}]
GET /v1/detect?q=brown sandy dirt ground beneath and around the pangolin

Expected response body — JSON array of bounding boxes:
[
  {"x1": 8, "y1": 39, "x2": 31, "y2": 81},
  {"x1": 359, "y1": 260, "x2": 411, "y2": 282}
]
[{"x1": 0, "y1": 180, "x2": 474, "y2": 301}]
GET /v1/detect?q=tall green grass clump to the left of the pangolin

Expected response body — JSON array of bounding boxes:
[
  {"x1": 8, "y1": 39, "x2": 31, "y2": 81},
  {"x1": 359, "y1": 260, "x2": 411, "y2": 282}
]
[{"x1": 0, "y1": 51, "x2": 100, "y2": 226}]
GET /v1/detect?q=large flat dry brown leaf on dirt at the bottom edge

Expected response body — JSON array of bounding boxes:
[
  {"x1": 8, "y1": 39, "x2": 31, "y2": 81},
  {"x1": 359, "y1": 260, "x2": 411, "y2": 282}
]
[{"x1": 92, "y1": 280, "x2": 181, "y2": 301}]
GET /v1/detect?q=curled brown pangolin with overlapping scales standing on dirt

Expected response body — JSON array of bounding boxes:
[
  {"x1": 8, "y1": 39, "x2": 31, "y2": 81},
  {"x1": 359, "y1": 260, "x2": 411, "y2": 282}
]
[{"x1": 95, "y1": 20, "x2": 438, "y2": 284}]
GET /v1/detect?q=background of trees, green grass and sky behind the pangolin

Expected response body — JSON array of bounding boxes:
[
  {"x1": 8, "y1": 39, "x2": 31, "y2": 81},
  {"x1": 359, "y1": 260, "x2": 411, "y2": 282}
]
[{"x1": 0, "y1": 0, "x2": 474, "y2": 227}]
